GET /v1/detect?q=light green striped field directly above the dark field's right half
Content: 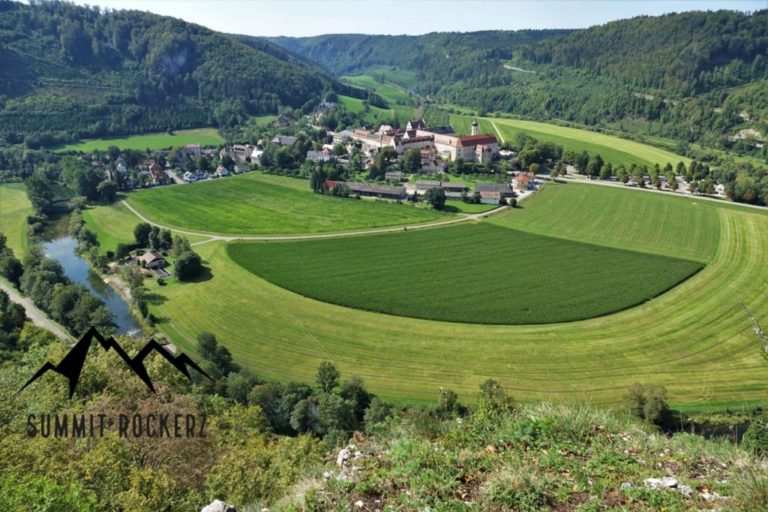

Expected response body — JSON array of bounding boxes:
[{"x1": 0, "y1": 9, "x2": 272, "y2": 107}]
[{"x1": 489, "y1": 183, "x2": 722, "y2": 262}]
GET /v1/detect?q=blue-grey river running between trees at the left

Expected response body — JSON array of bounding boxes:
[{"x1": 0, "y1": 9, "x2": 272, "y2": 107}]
[{"x1": 42, "y1": 233, "x2": 141, "y2": 336}]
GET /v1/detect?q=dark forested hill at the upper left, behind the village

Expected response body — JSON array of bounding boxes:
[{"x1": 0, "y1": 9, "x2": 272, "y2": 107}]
[{"x1": 0, "y1": 1, "x2": 335, "y2": 143}]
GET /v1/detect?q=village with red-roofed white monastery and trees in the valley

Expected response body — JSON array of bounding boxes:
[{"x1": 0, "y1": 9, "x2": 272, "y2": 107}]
[{"x1": 92, "y1": 111, "x2": 541, "y2": 205}]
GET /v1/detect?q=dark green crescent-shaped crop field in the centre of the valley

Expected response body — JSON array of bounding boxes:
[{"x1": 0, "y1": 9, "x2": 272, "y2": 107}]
[{"x1": 228, "y1": 224, "x2": 702, "y2": 324}]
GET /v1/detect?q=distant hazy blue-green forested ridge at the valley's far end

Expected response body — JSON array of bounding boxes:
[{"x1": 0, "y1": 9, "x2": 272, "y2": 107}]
[{"x1": 269, "y1": 30, "x2": 571, "y2": 93}]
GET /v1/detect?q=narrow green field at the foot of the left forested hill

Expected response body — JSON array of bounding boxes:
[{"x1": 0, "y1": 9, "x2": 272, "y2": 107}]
[{"x1": 57, "y1": 128, "x2": 224, "y2": 153}]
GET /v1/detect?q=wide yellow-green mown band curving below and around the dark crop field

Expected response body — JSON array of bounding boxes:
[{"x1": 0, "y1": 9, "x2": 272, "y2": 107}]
[{"x1": 144, "y1": 209, "x2": 768, "y2": 410}]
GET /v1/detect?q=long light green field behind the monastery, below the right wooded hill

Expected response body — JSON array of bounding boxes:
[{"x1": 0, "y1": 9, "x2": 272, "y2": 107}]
[{"x1": 488, "y1": 116, "x2": 691, "y2": 168}]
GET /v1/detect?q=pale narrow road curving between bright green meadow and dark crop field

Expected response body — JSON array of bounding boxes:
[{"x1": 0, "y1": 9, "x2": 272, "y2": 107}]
[{"x1": 123, "y1": 201, "x2": 507, "y2": 245}]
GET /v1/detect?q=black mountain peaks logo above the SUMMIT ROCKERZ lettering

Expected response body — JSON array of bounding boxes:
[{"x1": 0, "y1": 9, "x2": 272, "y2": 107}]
[{"x1": 17, "y1": 327, "x2": 213, "y2": 399}]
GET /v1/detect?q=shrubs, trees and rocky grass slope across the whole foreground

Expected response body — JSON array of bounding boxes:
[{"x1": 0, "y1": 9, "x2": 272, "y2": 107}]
[{"x1": 0, "y1": 324, "x2": 768, "y2": 511}]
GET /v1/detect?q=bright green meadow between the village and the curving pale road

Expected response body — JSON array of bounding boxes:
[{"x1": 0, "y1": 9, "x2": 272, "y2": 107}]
[{"x1": 128, "y1": 173, "x2": 448, "y2": 234}]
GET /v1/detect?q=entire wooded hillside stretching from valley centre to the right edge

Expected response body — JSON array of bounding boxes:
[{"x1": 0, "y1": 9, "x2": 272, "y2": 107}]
[{"x1": 271, "y1": 10, "x2": 768, "y2": 153}]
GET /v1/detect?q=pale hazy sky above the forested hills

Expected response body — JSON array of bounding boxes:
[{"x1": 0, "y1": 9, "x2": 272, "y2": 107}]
[{"x1": 67, "y1": 0, "x2": 768, "y2": 36}]
